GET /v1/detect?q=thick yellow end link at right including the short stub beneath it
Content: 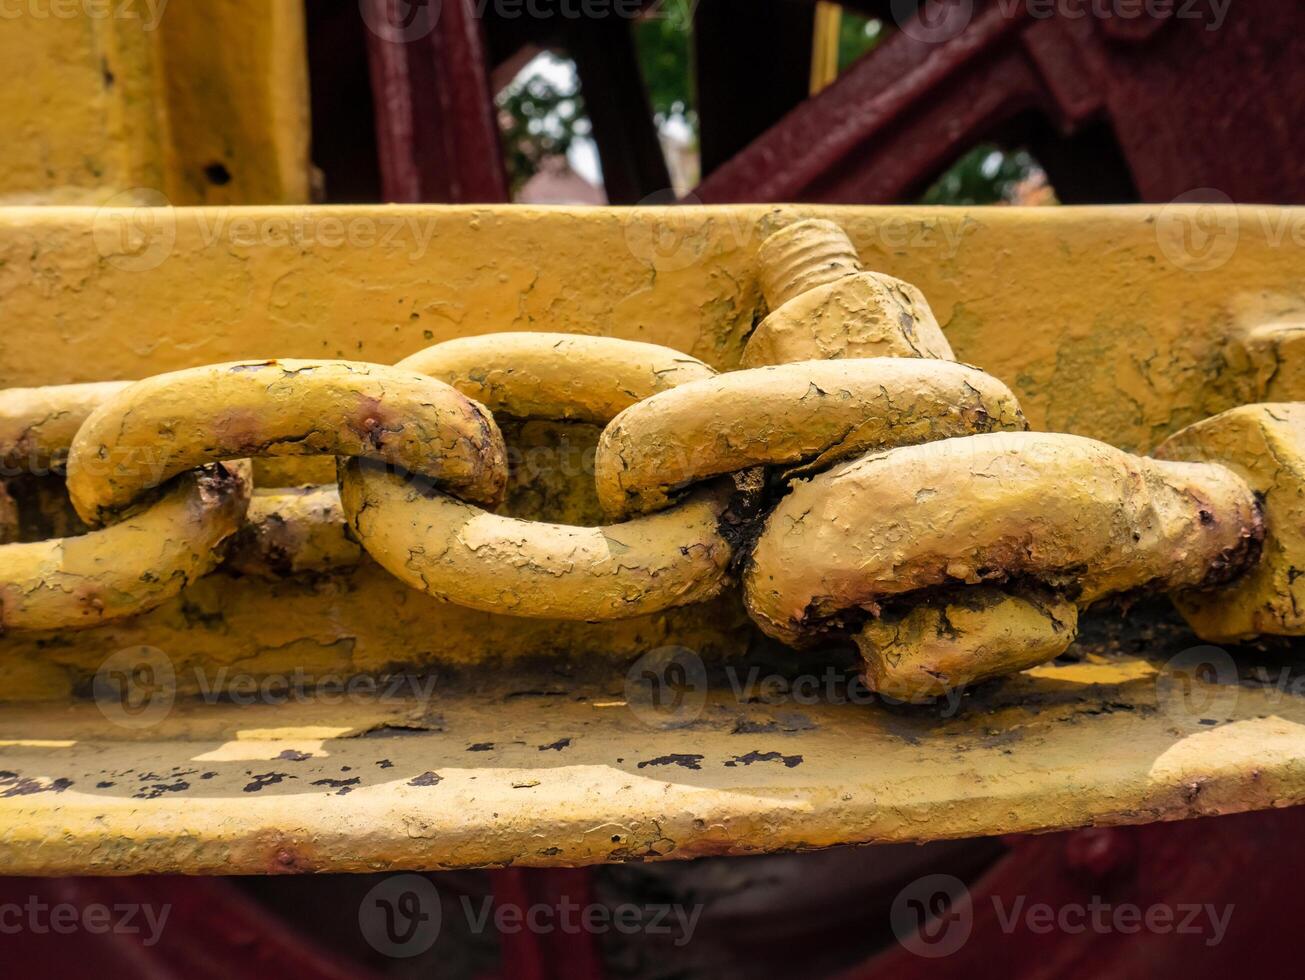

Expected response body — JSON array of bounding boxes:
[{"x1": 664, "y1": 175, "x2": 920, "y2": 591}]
[{"x1": 744, "y1": 432, "x2": 1268, "y2": 701}]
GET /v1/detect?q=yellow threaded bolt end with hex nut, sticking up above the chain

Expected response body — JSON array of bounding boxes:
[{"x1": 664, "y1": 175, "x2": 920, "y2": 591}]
[{"x1": 743, "y1": 219, "x2": 955, "y2": 368}]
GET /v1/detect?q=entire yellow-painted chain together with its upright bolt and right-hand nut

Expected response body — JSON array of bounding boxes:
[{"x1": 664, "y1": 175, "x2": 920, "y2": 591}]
[{"x1": 0, "y1": 221, "x2": 1305, "y2": 701}]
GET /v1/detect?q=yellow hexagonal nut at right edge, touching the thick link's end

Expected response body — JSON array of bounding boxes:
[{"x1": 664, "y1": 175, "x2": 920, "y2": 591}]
[{"x1": 1154, "y1": 402, "x2": 1305, "y2": 642}]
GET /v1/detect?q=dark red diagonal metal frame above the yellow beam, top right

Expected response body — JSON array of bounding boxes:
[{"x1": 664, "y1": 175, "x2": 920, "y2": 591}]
[{"x1": 693, "y1": 0, "x2": 1305, "y2": 204}]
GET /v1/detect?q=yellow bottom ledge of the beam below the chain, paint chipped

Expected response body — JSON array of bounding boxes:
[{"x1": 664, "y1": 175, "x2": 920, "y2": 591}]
[{"x1": 0, "y1": 611, "x2": 1305, "y2": 874}]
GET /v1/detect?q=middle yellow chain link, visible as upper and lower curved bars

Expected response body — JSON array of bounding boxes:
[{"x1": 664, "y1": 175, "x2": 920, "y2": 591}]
[{"x1": 341, "y1": 334, "x2": 752, "y2": 620}]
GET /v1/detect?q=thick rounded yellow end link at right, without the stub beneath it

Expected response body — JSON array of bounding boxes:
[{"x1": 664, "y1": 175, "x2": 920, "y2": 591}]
[{"x1": 745, "y1": 432, "x2": 1262, "y2": 678}]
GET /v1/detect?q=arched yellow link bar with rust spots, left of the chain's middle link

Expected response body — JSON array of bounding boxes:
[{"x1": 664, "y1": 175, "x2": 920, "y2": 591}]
[{"x1": 68, "y1": 360, "x2": 508, "y2": 523}]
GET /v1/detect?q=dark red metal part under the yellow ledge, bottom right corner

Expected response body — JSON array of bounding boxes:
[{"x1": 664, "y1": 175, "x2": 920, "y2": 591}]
[{"x1": 842, "y1": 803, "x2": 1305, "y2": 980}]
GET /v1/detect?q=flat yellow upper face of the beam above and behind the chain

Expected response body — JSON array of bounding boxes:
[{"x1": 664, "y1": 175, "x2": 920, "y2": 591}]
[{"x1": 0, "y1": 205, "x2": 1305, "y2": 452}]
